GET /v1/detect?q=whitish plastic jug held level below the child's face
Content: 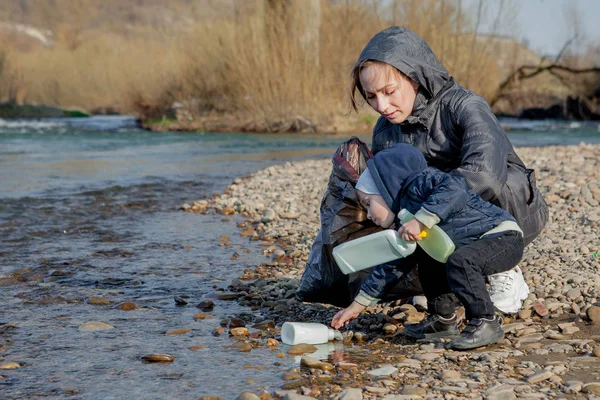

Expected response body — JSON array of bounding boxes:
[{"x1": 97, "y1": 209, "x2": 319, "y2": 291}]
[{"x1": 333, "y1": 229, "x2": 417, "y2": 275}]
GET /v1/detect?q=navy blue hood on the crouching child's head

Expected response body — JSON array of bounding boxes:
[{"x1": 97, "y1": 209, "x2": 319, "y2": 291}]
[{"x1": 367, "y1": 143, "x2": 427, "y2": 214}]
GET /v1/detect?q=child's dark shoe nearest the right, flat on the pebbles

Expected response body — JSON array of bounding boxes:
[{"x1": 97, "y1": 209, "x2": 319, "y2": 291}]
[{"x1": 450, "y1": 315, "x2": 504, "y2": 350}]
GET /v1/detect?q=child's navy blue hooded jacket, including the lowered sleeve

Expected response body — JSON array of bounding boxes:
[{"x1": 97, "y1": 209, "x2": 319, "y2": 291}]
[{"x1": 361, "y1": 143, "x2": 515, "y2": 298}]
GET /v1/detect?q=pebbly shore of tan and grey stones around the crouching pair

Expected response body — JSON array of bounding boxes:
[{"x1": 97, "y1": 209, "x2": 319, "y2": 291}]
[{"x1": 183, "y1": 144, "x2": 600, "y2": 400}]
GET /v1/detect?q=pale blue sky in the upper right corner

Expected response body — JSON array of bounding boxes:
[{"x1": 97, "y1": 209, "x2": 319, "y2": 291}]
[{"x1": 475, "y1": 0, "x2": 600, "y2": 56}]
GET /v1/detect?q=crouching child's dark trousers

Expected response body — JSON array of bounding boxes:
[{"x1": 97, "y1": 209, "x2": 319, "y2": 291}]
[{"x1": 415, "y1": 231, "x2": 524, "y2": 319}]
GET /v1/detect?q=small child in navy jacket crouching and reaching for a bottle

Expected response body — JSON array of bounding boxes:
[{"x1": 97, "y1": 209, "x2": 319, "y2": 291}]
[{"x1": 331, "y1": 144, "x2": 524, "y2": 350}]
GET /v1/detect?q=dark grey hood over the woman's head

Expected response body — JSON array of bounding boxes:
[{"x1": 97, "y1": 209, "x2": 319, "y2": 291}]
[{"x1": 358, "y1": 26, "x2": 450, "y2": 99}]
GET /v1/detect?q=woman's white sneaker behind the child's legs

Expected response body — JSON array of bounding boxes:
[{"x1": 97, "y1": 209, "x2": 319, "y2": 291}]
[{"x1": 488, "y1": 266, "x2": 529, "y2": 314}]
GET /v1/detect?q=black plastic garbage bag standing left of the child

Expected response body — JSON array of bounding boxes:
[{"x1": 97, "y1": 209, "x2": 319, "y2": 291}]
[{"x1": 296, "y1": 137, "x2": 422, "y2": 307}]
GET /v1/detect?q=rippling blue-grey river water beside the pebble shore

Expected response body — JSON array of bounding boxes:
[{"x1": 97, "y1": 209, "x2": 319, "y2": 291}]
[{"x1": 0, "y1": 117, "x2": 600, "y2": 399}]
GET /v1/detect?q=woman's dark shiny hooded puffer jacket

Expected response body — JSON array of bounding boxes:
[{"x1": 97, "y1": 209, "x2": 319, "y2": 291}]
[{"x1": 358, "y1": 26, "x2": 548, "y2": 244}]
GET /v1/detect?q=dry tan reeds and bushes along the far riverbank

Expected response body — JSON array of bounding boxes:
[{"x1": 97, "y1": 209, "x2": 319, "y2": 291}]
[{"x1": 0, "y1": 0, "x2": 589, "y2": 131}]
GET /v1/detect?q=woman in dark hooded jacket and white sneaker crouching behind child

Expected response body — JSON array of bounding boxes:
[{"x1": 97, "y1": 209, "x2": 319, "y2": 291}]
[{"x1": 344, "y1": 26, "x2": 548, "y2": 313}]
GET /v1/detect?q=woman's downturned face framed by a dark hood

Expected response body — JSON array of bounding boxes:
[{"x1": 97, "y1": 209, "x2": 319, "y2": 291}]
[{"x1": 360, "y1": 63, "x2": 419, "y2": 124}]
